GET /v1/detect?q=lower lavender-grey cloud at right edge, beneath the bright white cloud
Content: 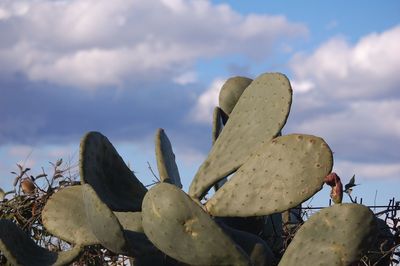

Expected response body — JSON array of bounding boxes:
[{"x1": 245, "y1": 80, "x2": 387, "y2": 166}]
[{"x1": 295, "y1": 100, "x2": 400, "y2": 164}]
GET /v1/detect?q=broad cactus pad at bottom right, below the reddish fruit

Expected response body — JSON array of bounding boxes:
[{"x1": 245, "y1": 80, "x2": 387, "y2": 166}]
[{"x1": 279, "y1": 203, "x2": 377, "y2": 266}]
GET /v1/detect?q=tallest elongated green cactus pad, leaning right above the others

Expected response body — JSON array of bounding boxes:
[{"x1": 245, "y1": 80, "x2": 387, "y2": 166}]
[{"x1": 189, "y1": 73, "x2": 292, "y2": 198}]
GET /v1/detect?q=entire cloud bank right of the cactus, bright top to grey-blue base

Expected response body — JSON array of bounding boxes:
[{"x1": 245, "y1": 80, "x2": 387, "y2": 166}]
[{"x1": 290, "y1": 26, "x2": 400, "y2": 179}]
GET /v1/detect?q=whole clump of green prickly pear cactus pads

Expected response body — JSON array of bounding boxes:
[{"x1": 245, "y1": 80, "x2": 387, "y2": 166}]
[{"x1": 0, "y1": 73, "x2": 384, "y2": 266}]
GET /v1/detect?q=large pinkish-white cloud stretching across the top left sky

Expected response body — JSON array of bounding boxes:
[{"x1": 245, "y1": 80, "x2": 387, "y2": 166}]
[{"x1": 0, "y1": 0, "x2": 307, "y2": 87}]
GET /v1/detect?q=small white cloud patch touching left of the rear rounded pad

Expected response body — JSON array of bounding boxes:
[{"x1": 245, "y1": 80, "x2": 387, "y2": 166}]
[{"x1": 189, "y1": 78, "x2": 225, "y2": 124}]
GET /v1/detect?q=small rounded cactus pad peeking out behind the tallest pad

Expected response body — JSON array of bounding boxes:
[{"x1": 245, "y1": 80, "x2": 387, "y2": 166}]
[{"x1": 219, "y1": 76, "x2": 253, "y2": 115}]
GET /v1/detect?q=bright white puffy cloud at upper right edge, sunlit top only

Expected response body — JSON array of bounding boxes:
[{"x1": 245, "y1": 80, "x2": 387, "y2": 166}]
[{"x1": 291, "y1": 26, "x2": 400, "y2": 100}]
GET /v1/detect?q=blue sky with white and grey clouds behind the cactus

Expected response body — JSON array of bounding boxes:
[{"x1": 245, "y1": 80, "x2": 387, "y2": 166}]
[{"x1": 0, "y1": 0, "x2": 400, "y2": 205}]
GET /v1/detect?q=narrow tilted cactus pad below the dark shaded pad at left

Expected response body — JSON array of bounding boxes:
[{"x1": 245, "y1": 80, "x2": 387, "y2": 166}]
[{"x1": 82, "y1": 184, "x2": 127, "y2": 253}]
